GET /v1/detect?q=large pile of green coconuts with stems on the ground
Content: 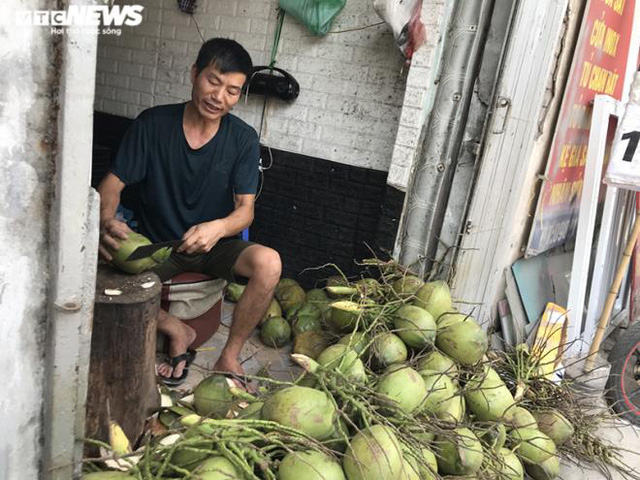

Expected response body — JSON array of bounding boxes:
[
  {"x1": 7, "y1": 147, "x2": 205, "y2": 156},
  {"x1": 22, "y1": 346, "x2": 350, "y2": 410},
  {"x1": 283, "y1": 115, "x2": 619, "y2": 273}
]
[{"x1": 85, "y1": 273, "x2": 616, "y2": 480}]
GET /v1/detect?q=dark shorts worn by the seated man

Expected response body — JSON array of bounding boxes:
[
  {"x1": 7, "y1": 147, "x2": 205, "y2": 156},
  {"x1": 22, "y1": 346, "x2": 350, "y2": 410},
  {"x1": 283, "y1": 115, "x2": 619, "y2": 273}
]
[{"x1": 152, "y1": 238, "x2": 257, "y2": 282}]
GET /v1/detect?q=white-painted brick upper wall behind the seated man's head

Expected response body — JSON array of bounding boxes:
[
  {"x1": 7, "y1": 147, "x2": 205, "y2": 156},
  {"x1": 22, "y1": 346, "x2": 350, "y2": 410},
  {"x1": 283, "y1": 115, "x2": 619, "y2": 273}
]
[{"x1": 96, "y1": 0, "x2": 405, "y2": 171}]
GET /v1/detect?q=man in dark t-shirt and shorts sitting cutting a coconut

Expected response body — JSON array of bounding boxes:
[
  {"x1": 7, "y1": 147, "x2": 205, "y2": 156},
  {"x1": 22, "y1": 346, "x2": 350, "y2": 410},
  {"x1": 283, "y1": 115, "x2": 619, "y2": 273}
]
[{"x1": 98, "y1": 38, "x2": 281, "y2": 385}]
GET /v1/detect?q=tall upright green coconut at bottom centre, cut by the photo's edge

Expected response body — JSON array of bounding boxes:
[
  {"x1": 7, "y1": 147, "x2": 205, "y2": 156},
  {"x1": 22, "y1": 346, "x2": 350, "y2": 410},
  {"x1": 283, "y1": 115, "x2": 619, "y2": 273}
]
[{"x1": 342, "y1": 425, "x2": 404, "y2": 480}]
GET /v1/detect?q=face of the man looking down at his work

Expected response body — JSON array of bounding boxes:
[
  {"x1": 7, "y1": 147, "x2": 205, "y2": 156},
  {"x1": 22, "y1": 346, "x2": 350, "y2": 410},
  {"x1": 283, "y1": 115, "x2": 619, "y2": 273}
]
[{"x1": 191, "y1": 65, "x2": 247, "y2": 121}]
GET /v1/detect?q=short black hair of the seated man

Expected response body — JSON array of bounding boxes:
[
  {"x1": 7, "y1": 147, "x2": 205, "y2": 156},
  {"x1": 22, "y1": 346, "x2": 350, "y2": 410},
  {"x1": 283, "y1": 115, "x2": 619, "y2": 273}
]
[{"x1": 196, "y1": 38, "x2": 253, "y2": 78}]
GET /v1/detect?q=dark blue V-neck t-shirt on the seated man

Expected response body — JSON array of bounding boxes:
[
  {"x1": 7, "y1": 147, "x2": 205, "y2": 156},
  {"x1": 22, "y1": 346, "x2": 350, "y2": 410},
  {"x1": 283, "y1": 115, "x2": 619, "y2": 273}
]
[{"x1": 112, "y1": 103, "x2": 260, "y2": 242}]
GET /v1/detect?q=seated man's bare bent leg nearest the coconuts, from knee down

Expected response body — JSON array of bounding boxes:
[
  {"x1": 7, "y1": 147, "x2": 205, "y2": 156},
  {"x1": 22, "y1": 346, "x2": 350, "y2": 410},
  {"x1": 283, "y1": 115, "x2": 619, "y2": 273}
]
[{"x1": 213, "y1": 245, "x2": 282, "y2": 375}]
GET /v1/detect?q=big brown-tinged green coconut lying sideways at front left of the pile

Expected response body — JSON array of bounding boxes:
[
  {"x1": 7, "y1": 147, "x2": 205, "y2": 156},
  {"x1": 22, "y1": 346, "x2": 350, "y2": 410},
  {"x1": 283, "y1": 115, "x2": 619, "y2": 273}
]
[{"x1": 261, "y1": 386, "x2": 338, "y2": 441}]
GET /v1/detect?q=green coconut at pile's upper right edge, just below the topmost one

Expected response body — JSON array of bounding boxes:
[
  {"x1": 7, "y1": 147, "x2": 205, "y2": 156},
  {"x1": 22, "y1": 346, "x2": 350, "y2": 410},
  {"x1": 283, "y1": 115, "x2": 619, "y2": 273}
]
[{"x1": 436, "y1": 317, "x2": 489, "y2": 366}]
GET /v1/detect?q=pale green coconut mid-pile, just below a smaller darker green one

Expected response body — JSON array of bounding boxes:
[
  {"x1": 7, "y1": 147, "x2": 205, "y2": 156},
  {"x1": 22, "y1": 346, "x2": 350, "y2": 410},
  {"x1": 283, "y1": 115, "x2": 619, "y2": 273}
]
[{"x1": 376, "y1": 366, "x2": 427, "y2": 413}]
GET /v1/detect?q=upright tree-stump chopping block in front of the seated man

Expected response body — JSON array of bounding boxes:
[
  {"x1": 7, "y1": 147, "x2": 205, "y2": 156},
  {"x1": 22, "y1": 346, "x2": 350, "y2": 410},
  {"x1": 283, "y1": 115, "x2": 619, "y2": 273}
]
[{"x1": 85, "y1": 265, "x2": 162, "y2": 443}]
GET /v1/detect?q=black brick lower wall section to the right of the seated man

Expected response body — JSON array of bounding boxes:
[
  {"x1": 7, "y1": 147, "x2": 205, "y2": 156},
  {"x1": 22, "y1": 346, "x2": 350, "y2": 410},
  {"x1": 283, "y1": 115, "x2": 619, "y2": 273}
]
[{"x1": 251, "y1": 150, "x2": 404, "y2": 288}]
